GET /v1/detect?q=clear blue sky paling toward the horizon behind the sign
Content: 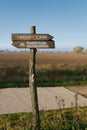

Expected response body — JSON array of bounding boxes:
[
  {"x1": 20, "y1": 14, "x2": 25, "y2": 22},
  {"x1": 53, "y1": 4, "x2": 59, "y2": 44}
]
[{"x1": 0, "y1": 0, "x2": 87, "y2": 51}]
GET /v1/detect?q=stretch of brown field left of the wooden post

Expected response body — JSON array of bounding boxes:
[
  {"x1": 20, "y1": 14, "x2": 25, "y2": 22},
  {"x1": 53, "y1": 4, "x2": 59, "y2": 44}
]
[{"x1": 0, "y1": 53, "x2": 28, "y2": 67}]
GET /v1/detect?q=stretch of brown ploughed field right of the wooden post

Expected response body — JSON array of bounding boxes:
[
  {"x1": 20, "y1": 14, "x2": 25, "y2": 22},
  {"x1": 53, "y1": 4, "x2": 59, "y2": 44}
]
[{"x1": 37, "y1": 53, "x2": 87, "y2": 64}]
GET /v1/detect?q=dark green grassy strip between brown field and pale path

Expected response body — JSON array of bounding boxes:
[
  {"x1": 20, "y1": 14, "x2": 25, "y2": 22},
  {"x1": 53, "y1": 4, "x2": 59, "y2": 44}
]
[{"x1": 0, "y1": 64, "x2": 87, "y2": 88}]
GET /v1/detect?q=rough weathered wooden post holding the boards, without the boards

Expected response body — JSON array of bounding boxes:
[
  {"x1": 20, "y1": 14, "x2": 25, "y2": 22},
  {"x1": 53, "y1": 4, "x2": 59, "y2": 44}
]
[{"x1": 29, "y1": 26, "x2": 40, "y2": 130}]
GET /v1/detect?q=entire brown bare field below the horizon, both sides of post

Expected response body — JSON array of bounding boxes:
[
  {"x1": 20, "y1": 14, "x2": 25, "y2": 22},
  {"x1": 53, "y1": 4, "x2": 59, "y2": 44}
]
[{"x1": 0, "y1": 52, "x2": 87, "y2": 67}]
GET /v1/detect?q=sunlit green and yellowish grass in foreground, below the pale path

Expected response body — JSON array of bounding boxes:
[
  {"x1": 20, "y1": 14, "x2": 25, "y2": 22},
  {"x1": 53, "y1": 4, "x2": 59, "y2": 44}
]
[{"x1": 0, "y1": 107, "x2": 87, "y2": 130}]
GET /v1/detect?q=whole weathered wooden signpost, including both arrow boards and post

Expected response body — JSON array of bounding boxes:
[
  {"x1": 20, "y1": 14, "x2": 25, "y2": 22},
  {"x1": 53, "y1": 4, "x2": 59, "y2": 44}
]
[{"x1": 12, "y1": 26, "x2": 55, "y2": 130}]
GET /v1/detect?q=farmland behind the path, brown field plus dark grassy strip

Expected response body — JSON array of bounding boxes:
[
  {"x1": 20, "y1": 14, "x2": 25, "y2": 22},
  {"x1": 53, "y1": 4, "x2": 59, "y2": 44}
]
[{"x1": 0, "y1": 52, "x2": 87, "y2": 87}]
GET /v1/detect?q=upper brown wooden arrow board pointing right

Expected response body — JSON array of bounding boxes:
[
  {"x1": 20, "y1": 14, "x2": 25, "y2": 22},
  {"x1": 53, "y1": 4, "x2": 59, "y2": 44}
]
[{"x1": 12, "y1": 34, "x2": 53, "y2": 41}]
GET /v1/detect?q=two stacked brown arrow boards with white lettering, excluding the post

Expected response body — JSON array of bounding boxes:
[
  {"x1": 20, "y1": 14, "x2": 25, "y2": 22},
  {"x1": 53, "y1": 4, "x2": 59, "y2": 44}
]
[{"x1": 12, "y1": 34, "x2": 55, "y2": 48}]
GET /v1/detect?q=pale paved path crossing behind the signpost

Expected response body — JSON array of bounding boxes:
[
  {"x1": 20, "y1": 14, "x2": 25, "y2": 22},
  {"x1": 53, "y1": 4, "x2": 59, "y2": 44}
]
[{"x1": 0, "y1": 87, "x2": 87, "y2": 114}]
